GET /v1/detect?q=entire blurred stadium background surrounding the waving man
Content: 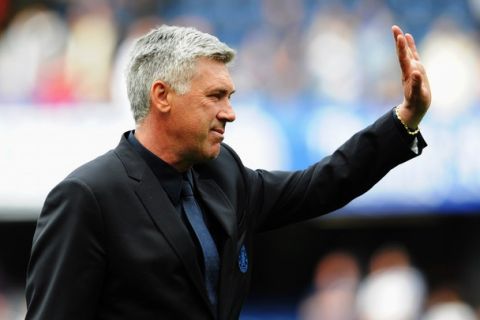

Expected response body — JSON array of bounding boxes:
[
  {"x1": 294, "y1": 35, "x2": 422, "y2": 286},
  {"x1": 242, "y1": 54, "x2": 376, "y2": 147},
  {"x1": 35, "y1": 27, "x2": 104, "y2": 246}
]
[{"x1": 0, "y1": 0, "x2": 480, "y2": 320}]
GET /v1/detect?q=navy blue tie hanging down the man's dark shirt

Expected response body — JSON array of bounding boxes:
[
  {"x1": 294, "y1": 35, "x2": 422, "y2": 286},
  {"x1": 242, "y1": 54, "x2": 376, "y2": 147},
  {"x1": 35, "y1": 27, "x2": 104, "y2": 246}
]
[{"x1": 182, "y1": 177, "x2": 220, "y2": 307}]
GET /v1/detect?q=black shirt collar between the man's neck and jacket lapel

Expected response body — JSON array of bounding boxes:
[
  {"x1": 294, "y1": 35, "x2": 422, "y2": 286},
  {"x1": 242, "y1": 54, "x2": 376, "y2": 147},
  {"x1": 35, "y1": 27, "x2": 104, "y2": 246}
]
[{"x1": 127, "y1": 131, "x2": 183, "y2": 205}]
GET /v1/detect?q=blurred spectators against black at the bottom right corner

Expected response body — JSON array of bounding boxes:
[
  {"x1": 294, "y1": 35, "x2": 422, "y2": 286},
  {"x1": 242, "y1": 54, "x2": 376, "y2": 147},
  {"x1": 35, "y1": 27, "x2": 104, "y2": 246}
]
[{"x1": 298, "y1": 244, "x2": 480, "y2": 320}]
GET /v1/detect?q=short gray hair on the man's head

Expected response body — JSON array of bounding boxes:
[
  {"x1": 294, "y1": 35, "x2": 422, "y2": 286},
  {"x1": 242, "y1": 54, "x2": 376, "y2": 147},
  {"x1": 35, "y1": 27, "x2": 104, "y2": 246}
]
[{"x1": 126, "y1": 25, "x2": 235, "y2": 123}]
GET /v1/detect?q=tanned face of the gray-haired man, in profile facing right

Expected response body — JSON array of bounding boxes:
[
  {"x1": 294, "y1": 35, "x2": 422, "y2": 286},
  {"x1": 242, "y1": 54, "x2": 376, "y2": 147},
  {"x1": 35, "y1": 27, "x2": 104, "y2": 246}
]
[{"x1": 168, "y1": 58, "x2": 235, "y2": 164}]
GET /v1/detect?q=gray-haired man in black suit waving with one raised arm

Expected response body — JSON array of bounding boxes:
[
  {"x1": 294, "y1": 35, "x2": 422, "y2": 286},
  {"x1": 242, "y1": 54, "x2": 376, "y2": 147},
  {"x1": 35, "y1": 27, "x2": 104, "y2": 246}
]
[{"x1": 26, "y1": 26, "x2": 430, "y2": 320}]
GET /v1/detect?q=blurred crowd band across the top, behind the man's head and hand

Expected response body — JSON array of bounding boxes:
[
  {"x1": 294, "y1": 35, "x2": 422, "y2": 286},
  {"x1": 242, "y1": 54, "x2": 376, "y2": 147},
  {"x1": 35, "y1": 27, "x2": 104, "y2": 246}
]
[{"x1": 0, "y1": 0, "x2": 480, "y2": 116}]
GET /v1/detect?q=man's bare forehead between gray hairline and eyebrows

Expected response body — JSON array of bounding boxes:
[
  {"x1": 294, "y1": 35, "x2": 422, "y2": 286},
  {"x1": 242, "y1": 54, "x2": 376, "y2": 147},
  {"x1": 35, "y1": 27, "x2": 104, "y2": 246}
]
[{"x1": 191, "y1": 58, "x2": 234, "y2": 91}]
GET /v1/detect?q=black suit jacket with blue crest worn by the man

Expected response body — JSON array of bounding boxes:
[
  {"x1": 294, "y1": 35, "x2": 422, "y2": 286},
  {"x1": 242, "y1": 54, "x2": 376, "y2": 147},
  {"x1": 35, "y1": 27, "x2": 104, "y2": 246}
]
[{"x1": 26, "y1": 112, "x2": 425, "y2": 320}]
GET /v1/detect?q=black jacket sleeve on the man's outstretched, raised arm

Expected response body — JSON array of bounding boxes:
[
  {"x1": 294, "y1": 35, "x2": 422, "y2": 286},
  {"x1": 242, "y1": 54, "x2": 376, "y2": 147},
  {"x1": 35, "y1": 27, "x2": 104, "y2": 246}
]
[{"x1": 247, "y1": 111, "x2": 426, "y2": 231}]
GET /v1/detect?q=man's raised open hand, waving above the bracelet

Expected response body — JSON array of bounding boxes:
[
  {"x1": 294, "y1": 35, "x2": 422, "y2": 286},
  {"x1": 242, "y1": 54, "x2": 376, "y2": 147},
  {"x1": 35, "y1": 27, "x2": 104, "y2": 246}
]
[{"x1": 392, "y1": 26, "x2": 432, "y2": 129}]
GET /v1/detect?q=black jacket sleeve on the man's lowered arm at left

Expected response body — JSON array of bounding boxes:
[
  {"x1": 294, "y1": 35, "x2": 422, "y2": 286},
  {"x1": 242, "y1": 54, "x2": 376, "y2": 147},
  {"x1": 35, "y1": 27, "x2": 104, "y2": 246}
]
[{"x1": 26, "y1": 179, "x2": 106, "y2": 320}]
